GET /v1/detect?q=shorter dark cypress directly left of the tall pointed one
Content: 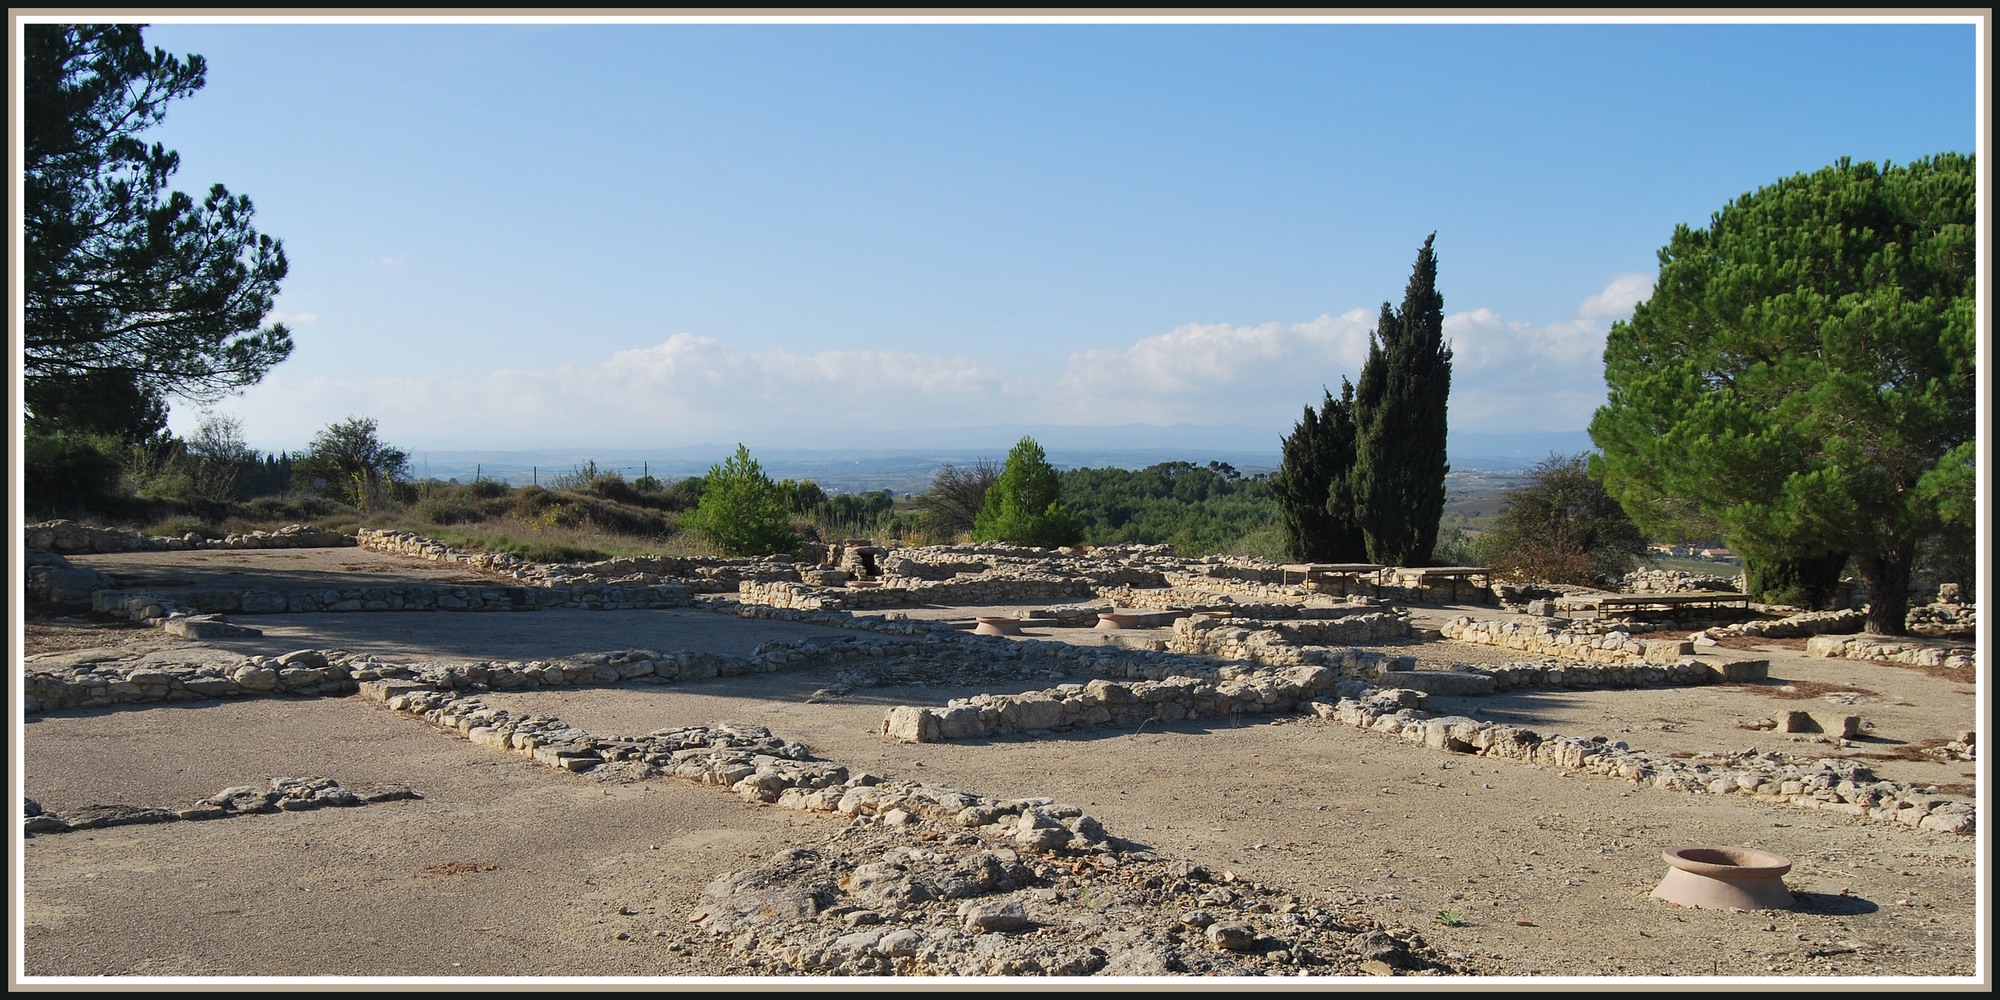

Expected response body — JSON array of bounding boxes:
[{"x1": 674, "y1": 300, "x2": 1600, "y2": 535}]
[{"x1": 1270, "y1": 378, "x2": 1368, "y2": 562}]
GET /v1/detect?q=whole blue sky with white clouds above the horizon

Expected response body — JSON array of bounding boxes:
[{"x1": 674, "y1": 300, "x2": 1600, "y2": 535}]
[{"x1": 15, "y1": 18, "x2": 1984, "y2": 450}]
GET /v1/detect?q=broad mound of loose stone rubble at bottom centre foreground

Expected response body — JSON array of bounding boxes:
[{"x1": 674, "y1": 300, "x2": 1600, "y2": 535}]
[{"x1": 688, "y1": 824, "x2": 1478, "y2": 976}]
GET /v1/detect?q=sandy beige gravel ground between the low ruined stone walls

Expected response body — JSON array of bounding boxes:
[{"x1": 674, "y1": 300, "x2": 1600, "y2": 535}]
[{"x1": 14, "y1": 550, "x2": 1986, "y2": 986}]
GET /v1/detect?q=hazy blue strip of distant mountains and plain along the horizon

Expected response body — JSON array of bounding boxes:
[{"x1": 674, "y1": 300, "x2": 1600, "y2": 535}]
[{"x1": 410, "y1": 424, "x2": 1592, "y2": 492}]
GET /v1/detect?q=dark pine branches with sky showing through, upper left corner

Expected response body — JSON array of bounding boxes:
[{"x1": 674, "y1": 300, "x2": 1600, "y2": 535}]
[{"x1": 22, "y1": 24, "x2": 292, "y2": 434}]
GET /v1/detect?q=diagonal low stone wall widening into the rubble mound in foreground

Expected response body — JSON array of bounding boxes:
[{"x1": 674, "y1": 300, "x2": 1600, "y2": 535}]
[{"x1": 364, "y1": 682, "x2": 1448, "y2": 976}]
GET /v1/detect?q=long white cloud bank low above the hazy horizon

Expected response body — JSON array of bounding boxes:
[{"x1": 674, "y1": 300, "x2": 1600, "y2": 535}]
[{"x1": 195, "y1": 276, "x2": 1646, "y2": 448}]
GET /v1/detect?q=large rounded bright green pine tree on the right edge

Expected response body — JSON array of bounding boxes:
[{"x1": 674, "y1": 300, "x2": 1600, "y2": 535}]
[{"x1": 1590, "y1": 154, "x2": 1978, "y2": 634}]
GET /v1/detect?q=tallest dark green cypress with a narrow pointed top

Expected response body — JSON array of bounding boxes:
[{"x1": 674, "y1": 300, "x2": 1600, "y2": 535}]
[{"x1": 1348, "y1": 232, "x2": 1452, "y2": 566}]
